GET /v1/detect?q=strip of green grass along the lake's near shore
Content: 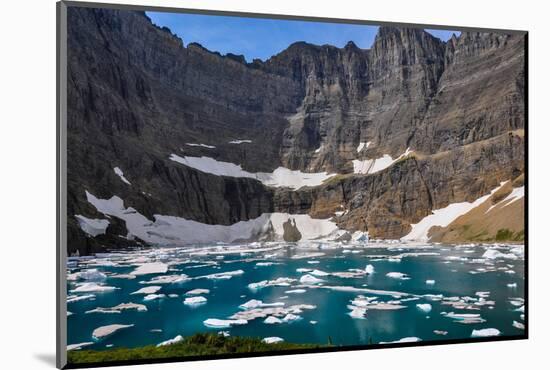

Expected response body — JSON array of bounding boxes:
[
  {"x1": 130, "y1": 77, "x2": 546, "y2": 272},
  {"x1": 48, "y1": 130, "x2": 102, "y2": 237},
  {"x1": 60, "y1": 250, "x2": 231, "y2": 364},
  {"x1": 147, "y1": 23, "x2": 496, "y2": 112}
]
[{"x1": 67, "y1": 334, "x2": 322, "y2": 364}]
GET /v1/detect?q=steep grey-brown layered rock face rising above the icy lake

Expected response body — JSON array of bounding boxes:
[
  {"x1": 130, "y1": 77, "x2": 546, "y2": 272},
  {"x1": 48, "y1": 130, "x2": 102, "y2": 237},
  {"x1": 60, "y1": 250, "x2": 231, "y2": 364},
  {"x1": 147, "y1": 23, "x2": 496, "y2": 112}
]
[{"x1": 67, "y1": 7, "x2": 525, "y2": 255}]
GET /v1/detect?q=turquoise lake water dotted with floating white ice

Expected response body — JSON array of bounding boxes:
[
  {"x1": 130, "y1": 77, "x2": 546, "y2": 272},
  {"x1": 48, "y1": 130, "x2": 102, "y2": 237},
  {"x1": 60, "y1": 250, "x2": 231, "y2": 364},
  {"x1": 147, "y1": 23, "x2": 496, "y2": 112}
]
[{"x1": 67, "y1": 243, "x2": 524, "y2": 350}]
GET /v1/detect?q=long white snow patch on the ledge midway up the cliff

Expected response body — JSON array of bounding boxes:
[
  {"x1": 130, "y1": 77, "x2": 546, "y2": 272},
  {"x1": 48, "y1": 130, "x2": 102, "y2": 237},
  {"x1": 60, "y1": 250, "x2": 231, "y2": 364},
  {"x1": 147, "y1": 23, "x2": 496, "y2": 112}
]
[{"x1": 170, "y1": 154, "x2": 336, "y2": 189}]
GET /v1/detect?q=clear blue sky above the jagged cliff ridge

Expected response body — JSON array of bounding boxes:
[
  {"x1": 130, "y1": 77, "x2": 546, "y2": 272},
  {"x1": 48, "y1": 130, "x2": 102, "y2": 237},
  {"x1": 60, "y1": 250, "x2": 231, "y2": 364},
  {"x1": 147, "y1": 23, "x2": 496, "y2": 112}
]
[{"x1": 147, "y1": 12, "x2": 460, "y2": 62}]
